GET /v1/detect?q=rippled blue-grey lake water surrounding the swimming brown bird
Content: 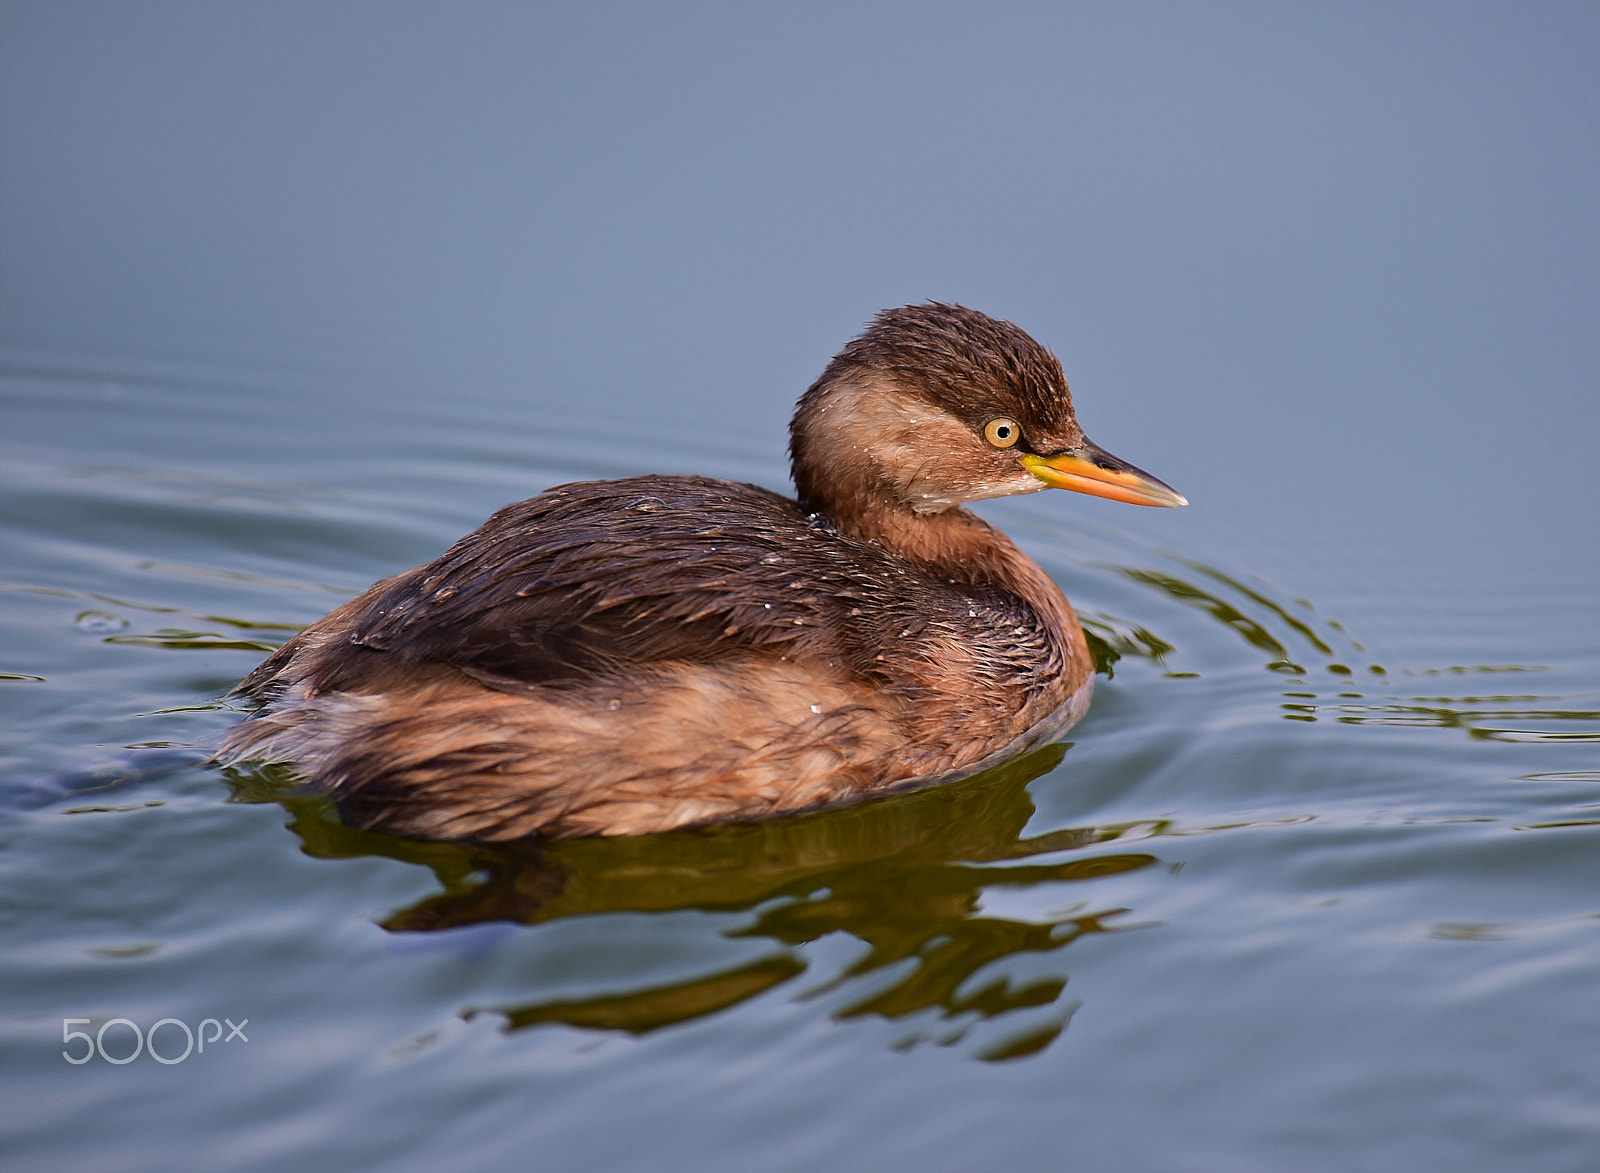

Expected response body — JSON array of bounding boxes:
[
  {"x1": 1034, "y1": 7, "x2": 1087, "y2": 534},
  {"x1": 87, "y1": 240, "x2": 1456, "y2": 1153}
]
[{"x1": 9, "y1": 3, "x2": 1600, "y2": 1171}]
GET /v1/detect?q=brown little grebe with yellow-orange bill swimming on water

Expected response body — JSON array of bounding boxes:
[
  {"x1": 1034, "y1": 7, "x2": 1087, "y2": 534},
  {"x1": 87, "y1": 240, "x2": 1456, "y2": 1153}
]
[{"x1": 222, "y1": 302, "x2": 1186, "y2": 840}]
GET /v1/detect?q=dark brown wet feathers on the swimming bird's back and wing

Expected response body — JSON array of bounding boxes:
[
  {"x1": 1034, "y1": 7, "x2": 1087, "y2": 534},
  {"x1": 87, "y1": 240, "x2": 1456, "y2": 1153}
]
[{"x1": 320, "y1": 477, "x2": 925, "y2": 691}]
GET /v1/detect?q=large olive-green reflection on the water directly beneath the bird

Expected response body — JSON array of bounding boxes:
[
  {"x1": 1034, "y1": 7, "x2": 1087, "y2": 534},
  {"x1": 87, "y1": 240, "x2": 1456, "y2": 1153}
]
[{"x1": 229, "y1": 746, "x2": 1158, "y2": 1059}]
